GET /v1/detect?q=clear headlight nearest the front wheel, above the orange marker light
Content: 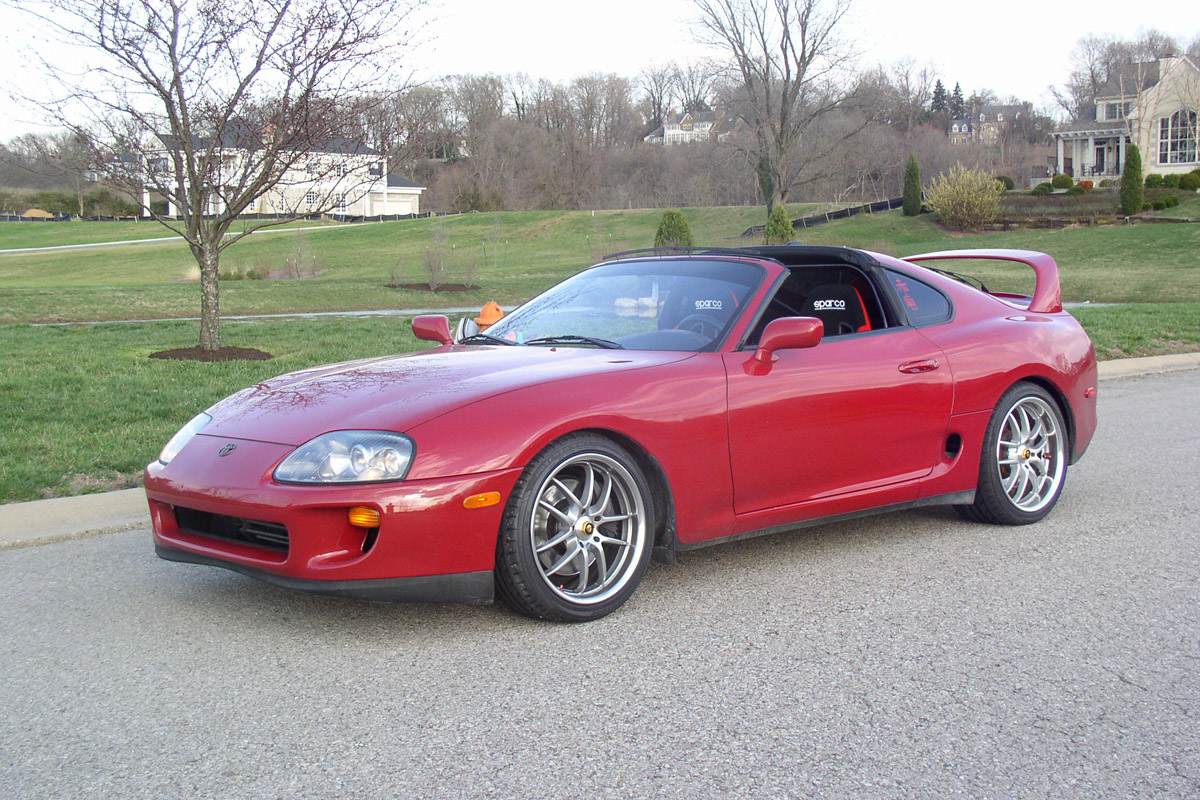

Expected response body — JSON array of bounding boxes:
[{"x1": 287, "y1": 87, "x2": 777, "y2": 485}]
[{"x1": 275, "y1": 431, "x2": 415, "y2": 483}]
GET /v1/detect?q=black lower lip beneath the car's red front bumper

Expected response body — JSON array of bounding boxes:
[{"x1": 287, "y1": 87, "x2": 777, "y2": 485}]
[{"x1": 155, "y1": 543, "x2": 494, "y2": 604}]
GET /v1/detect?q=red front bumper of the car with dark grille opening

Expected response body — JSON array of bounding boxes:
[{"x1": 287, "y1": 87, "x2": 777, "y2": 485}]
[{"x1": 145, "y1": 437, "x2": 520, "y2": 603}]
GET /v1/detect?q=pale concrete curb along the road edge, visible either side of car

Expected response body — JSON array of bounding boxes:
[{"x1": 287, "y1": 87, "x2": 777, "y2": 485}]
[{"x1": 0, "y1": 353, "x2": 1200, "y2": 551}]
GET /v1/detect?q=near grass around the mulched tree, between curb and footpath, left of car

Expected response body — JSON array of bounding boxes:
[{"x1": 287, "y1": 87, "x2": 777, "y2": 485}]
[{"x1": 0, "y1": 318, "x2": 428, "y2": 503}]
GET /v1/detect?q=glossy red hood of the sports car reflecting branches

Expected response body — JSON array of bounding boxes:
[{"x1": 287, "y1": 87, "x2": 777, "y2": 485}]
[{"x1": 204, "y1": 345, "x2": 692, "y2": 445}]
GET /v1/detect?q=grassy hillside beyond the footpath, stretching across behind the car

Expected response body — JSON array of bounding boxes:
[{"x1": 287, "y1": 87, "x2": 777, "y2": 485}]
[{"x1": 0, "y1": 205, "x2": 1200, "y2": 324}]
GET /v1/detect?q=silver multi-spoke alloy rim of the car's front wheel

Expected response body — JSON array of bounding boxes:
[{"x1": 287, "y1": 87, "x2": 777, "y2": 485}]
[{"x1": 529, "y1": 452, "x2": 647, "y2": 604}]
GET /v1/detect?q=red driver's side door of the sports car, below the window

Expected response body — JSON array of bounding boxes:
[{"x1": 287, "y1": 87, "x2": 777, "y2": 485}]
[{"x1": 725, "y1": 327, "x2": 953, "y2": 515}]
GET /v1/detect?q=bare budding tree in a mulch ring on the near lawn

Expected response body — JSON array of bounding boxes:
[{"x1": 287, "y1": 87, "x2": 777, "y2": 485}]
[{"x1": 10, "y1": 0, "x2": 424, "y2": 350}]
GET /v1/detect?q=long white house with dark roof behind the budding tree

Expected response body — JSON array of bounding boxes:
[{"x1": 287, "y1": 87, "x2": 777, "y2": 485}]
[{"x1": 143, "y1": 131, "x2": 425, "y2": 217}]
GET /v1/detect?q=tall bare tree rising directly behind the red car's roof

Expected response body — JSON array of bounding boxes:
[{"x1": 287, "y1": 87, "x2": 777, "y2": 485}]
[{"x1": 695, "y1": 0, "x2": 865, "y2": 207}]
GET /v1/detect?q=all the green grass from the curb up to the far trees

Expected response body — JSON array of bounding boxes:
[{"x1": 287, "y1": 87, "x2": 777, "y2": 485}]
[{"x1": 0, "y1": 206, "x2": 1200, "y2": 503}]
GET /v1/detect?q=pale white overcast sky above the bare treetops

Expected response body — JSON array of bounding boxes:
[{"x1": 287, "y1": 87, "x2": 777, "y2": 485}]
[{"x1": 0, "y1": 0, "x2": 1200, "y2": 140}]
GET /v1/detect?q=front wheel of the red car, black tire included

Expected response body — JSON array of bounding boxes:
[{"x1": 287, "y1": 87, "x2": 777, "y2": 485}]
[{"x1": 496, "y1": 433, "x2": 654, "y2": 622}]
